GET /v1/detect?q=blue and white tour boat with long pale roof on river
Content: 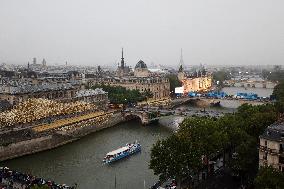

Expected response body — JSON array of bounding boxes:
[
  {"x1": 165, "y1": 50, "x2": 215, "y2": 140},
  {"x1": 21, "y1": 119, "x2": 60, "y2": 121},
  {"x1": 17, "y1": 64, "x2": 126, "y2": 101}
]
[{"x1": 103, "y1": 141, "x2": 141, "y2": 164}]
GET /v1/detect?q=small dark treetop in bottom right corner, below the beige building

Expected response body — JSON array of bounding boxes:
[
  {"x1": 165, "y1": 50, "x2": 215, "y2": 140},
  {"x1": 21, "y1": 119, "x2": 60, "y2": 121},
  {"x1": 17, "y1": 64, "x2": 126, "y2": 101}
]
[{"x1": 254, "y1": 167, "x2": 284, "y2": 189}]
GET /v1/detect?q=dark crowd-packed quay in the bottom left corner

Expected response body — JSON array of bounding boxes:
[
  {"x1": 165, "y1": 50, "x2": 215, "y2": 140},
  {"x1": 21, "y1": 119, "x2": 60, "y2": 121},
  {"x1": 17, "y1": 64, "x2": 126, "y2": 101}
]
[{"x1": 0, "y1": 167, "x2": 76, "y2": 189}]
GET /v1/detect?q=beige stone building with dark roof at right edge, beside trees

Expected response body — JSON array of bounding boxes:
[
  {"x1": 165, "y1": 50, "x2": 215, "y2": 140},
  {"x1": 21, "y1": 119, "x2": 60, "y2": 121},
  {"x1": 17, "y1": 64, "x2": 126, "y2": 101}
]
[{"x1": 259, "y1": 122, "x2": 284, "y2": 172}]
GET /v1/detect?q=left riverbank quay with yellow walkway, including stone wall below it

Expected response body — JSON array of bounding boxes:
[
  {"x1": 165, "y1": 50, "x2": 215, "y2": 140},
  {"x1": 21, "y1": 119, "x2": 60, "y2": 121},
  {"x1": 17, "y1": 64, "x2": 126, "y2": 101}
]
[{"x1": 0, "y1": 111, "x2": 124, "y2": 161}]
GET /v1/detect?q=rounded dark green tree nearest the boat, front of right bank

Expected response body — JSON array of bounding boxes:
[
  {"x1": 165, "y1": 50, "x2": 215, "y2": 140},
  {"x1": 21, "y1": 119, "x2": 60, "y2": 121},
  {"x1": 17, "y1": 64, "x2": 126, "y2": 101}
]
[{"x1": 149, "y1": 134, "x2": 202, "y2": 186}]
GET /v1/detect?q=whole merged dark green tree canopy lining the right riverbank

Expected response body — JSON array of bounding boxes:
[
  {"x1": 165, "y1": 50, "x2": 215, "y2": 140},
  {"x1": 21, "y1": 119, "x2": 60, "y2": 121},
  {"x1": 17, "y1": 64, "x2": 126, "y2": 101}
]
[{"x1": 150, "y1": 104, "x2": 277, "y2": 188}]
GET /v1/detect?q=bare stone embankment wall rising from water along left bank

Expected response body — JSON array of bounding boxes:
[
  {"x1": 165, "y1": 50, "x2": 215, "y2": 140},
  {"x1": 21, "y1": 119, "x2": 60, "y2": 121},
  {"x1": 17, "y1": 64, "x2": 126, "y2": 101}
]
[{"x1": 0, "y1": 113, "x2": 124, "y2": 161}]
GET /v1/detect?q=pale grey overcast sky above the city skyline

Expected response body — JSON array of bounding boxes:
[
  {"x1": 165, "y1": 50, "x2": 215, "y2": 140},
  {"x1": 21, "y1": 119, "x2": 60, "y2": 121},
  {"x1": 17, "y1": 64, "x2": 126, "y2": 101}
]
[{"x1": 0, "y1": 0, "x2": 284, "y2": 67}]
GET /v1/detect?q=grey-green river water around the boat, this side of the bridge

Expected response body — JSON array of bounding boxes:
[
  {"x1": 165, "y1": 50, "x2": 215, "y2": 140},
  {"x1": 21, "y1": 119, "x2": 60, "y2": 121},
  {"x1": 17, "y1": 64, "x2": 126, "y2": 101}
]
[{"x1": 0, "y1": 121, "x2": 173, "y2": 189}]
